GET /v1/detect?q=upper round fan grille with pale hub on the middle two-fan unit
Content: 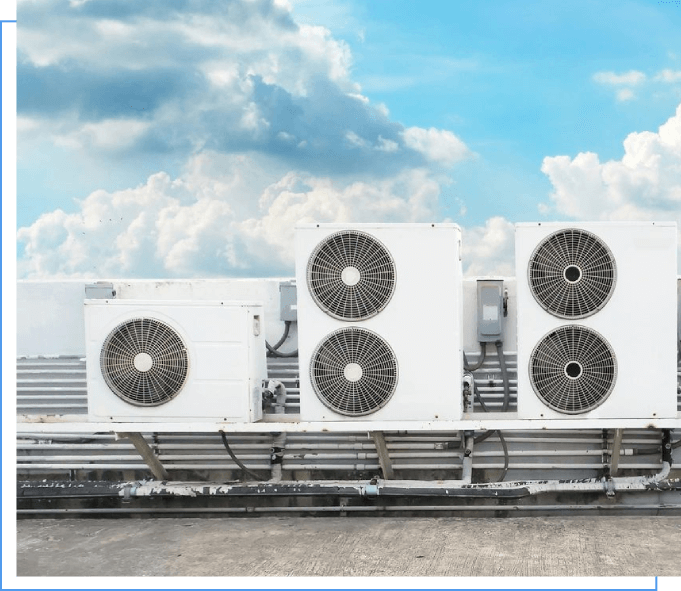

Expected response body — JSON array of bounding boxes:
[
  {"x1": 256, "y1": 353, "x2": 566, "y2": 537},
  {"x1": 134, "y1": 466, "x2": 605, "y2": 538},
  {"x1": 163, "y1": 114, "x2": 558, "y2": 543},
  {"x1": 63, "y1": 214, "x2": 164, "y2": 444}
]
[{"x1": 307, "y1": 230, "x2": 395, "y2": 321}]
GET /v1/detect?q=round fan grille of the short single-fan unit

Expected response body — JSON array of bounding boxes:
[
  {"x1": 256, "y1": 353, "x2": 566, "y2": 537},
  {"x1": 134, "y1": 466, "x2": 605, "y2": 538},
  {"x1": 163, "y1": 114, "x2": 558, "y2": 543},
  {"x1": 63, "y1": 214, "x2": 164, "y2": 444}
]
[{"x1": 99, "y1": 318, "x2": 189, "y2": 406}]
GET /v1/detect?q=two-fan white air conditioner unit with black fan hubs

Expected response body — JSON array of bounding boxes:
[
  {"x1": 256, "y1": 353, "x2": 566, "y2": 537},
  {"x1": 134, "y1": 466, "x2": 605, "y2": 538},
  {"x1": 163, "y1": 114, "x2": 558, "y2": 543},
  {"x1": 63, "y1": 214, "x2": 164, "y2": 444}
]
[{"x1": 515, "y1": 222, "x2": 677, "y2": 421}]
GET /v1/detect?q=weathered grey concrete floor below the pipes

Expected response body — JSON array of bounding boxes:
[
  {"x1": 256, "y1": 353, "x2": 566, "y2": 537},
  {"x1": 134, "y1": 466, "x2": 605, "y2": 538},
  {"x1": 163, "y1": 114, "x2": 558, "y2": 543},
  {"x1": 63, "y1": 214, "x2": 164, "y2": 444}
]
[{"x1": 16, "y1": 517, "x2": 681, "y2": 577}]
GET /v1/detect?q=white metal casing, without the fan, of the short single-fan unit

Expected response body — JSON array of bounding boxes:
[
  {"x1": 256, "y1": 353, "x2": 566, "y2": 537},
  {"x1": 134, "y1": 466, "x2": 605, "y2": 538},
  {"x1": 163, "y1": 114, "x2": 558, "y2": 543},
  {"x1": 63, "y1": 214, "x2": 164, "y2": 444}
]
[{"x1": 85, "y1": 299, "x2": 267, "y2": 422}]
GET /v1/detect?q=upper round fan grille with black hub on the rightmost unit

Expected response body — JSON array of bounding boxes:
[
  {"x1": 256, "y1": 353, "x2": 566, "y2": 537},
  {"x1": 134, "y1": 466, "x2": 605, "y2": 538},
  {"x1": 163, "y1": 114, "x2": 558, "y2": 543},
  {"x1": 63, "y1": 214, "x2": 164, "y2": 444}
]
[{"x1": 528, "y1": 229, "x2": 616, "y2": 319}]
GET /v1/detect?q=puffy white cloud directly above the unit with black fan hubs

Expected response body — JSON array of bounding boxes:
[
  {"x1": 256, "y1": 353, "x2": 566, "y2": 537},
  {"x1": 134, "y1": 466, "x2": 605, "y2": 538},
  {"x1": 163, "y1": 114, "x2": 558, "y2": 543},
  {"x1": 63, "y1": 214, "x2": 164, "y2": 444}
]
[{"x1": 541, "y1": 105, "x2": 681, "y2": 250}]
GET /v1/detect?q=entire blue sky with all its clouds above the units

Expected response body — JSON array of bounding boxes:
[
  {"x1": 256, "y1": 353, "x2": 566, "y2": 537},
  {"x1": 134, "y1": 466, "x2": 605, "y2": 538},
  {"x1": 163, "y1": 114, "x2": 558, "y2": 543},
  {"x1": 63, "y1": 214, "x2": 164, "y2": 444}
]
[{"x1": 16, "y1": 0, "x2": 681, "y2": 279}]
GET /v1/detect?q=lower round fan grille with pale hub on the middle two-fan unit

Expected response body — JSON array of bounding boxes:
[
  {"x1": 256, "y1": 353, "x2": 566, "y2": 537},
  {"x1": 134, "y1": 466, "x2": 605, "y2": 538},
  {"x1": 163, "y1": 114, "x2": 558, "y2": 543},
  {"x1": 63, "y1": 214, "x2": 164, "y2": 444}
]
[{"x1": 310, "y1": 328, "x2": 397, "y2": 416}]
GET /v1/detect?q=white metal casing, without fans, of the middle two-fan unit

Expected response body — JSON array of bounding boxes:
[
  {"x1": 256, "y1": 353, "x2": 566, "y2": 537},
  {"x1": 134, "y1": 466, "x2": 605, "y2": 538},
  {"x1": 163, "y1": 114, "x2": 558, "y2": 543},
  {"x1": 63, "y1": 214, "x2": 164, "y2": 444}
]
[{"x1": 295, "y1": 224, "x2": 463, "y2": 423}]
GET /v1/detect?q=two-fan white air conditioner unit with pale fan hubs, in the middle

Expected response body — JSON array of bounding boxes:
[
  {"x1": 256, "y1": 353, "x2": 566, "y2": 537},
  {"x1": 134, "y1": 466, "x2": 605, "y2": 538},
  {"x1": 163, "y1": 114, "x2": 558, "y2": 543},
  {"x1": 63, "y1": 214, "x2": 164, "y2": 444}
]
[{"x1": 296, "y1": 224, "x2": 462, "y2": 422}]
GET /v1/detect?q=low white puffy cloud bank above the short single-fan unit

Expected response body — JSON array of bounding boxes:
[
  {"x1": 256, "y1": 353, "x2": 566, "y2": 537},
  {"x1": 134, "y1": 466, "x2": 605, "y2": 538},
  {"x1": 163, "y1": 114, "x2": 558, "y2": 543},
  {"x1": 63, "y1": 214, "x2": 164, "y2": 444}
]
[{"x1": 17, "y1": 154, "x2": 440, "y2": 278}]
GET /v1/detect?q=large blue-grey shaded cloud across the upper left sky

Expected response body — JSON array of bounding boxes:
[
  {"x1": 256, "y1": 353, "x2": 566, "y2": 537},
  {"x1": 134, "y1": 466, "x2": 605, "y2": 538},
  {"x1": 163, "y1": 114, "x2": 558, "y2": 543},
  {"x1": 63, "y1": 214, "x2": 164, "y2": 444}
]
[{"x1": 17, "y1": 0, "x2": 467, "y2": 175}]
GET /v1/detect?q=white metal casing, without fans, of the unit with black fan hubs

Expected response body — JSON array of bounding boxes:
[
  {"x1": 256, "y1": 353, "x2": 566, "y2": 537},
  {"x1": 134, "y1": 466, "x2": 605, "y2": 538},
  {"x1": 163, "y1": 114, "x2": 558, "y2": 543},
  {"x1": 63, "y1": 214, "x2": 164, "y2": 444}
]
[{"x1": 515, "y1": 222, "x2": 677, "y2": 422}]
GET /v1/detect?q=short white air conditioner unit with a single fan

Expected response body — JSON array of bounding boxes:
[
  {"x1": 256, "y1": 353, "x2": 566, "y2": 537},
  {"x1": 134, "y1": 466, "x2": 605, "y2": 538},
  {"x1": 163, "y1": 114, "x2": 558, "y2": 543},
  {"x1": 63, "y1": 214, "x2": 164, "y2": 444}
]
[{"x1": 85, "y1": 299, "x2": 267, "y2": 422}]
